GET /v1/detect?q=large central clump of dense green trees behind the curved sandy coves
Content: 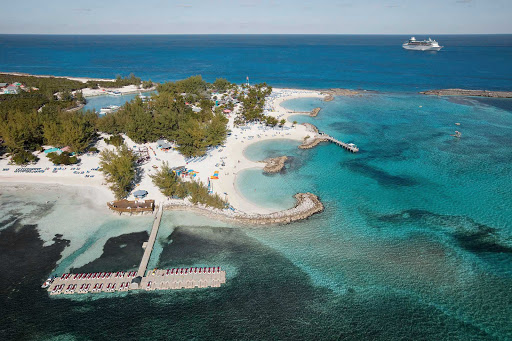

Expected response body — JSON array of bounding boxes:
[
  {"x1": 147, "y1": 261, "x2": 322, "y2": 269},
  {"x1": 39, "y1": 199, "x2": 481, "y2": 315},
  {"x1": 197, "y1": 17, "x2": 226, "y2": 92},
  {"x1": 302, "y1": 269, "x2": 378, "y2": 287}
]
[{"x1": 98, "y1": 76, "x2": 228, "y2": 156}]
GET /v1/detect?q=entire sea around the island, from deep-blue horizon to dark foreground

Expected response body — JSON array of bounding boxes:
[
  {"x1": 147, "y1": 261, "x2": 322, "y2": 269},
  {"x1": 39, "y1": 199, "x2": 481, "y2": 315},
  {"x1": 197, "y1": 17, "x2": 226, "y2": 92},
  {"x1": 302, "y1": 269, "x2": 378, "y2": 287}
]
[{"x1": 0, "y1": 35, "x2": 512, "y2": 340}]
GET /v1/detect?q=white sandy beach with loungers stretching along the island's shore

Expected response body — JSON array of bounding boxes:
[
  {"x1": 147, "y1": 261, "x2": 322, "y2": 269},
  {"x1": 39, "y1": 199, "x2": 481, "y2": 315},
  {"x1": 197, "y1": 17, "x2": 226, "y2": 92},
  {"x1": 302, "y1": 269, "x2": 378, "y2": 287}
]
[{"x1": 0, "y1": 89, "x2": 324, "y2": 213}]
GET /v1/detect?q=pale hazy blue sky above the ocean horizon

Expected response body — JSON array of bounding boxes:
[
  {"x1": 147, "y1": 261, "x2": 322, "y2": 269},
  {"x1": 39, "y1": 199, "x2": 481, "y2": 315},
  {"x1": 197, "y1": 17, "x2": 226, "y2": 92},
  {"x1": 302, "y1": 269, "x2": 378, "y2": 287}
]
[{"x1": 0, "y1": 0, "x2": 512, "y2": 34}]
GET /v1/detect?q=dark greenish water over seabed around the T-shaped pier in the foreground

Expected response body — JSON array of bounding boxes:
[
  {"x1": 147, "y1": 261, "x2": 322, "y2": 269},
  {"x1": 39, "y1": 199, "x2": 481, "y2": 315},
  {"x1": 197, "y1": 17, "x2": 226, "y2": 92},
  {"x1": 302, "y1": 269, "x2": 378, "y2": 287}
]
[{"x1": 0, "y1": 216, "x2": 504, "y2": 340}]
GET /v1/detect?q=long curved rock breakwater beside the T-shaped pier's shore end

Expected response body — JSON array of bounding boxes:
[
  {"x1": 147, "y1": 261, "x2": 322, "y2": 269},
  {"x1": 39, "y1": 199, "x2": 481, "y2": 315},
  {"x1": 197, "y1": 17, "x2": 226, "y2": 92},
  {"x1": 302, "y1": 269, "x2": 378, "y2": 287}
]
[{"x1": 163, "y1": 193, "x2": 324, "y2": 225}]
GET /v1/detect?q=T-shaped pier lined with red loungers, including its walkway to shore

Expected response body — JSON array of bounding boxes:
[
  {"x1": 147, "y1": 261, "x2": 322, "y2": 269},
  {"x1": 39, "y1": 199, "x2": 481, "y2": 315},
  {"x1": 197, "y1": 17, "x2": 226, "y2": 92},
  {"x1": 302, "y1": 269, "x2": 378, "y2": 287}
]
[{"x1": 48, "y1": 200, "x2": 226, "y2": 295}]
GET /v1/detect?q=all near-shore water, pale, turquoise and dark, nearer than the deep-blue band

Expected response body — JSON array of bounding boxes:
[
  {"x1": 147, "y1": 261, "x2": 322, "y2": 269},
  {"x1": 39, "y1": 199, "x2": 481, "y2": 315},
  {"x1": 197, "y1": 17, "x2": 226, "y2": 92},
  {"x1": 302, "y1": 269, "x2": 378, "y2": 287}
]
[{"x1": 0, "y1": 94, "x2": 512, "y2": 340}]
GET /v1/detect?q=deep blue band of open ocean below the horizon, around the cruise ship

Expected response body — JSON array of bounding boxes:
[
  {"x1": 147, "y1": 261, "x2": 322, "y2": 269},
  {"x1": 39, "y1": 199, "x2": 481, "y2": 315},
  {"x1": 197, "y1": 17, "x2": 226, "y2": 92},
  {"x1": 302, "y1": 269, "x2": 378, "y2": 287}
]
[{"x1": 0, "y1": 35, "x2": 512, "y2": 92}]
